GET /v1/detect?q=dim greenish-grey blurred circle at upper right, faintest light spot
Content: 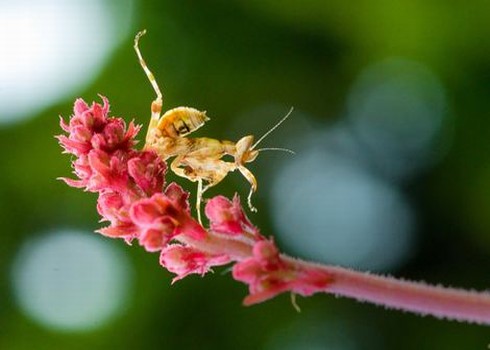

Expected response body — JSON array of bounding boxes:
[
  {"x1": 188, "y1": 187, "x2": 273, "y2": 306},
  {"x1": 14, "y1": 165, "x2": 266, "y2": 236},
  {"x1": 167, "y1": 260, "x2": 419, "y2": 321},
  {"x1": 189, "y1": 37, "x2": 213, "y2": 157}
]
[{"x1": 347, "y1": 58, "x2": 448, "y2": 180}]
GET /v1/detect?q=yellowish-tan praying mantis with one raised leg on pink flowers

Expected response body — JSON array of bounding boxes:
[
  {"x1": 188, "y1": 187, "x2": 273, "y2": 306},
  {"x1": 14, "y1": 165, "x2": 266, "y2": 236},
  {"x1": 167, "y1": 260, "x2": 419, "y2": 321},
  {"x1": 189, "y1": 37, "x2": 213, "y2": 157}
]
[{"x1": 134, "y1": 30, "x2": 294, "y2": 223}]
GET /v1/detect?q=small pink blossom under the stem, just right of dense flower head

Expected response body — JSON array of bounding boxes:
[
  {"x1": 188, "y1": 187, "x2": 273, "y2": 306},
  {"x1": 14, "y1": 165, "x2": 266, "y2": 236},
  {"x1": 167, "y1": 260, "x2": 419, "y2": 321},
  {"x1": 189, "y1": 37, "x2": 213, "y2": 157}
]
[{"x1": 160, "y1": 244, "x2": 231, "y2": 282}]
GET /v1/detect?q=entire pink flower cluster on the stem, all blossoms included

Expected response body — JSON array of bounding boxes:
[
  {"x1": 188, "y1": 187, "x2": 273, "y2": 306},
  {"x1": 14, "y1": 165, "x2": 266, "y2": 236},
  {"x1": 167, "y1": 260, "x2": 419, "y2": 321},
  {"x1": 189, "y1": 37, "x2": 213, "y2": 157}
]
[{"x1": 58, "y1": 97, "x2": 332, "y2": 305}]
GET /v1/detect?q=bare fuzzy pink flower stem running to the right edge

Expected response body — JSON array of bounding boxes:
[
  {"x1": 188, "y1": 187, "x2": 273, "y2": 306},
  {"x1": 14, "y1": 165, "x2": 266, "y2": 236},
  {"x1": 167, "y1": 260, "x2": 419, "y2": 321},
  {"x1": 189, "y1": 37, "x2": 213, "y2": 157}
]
[{"x1": 286, "y1": 258, "x2": 490, "y2": 324}]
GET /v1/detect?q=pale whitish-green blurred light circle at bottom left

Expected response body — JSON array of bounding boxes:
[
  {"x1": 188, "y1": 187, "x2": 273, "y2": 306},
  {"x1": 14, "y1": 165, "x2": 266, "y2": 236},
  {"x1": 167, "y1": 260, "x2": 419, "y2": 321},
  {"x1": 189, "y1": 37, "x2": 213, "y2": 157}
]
[{"x1": 12, "y1": 230, "x2": 132, "y2": 331}]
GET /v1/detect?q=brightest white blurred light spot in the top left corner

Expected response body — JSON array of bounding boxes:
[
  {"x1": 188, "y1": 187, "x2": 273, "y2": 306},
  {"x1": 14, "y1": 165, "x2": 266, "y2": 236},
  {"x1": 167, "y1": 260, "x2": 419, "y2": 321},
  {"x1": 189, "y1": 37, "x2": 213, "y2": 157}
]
[{"x1": 0, "y1": 0, "x2": 134, "y2": 125}]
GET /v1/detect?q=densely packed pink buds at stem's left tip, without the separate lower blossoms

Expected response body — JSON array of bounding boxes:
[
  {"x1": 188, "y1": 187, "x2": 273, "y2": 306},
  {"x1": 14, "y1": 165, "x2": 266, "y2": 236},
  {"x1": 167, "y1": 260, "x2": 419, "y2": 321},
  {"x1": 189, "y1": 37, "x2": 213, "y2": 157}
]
[{"x1": 58, "y1": 97, "x2": 206, "y2": 251}]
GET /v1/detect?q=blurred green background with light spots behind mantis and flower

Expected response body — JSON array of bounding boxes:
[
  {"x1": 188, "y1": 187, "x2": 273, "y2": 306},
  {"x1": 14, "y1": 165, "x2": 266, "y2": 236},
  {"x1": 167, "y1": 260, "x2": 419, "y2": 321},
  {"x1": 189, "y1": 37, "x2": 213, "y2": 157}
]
[{"x1": 0, "y1": 0, "x2": 490, "y2": 350}]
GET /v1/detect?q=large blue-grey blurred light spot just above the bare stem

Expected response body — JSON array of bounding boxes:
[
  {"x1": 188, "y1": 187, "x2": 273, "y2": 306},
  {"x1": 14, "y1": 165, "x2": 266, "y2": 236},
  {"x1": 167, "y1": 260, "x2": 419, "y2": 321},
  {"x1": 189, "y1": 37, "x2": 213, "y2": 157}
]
[{"x1": 271, "y1": 137, "x2": 414, "y2": 270}]
